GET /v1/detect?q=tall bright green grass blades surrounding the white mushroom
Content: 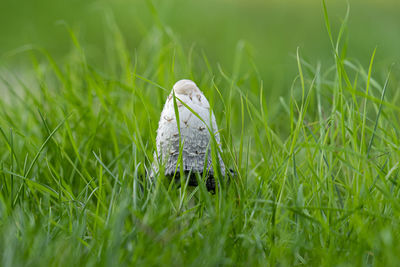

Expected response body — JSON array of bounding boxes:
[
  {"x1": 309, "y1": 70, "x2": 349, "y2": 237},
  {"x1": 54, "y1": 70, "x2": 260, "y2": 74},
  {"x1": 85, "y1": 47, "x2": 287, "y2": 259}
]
[{"x1": 0, "y1": 1, "x2": 400, "y2": 266}]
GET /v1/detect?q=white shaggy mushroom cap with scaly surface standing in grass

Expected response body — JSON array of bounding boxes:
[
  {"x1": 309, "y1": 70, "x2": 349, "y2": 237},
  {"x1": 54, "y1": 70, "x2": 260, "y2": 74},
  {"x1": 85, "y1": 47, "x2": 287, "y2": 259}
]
[{"x1": 152, "y1": 80, "x2": 225, "y2": 190}]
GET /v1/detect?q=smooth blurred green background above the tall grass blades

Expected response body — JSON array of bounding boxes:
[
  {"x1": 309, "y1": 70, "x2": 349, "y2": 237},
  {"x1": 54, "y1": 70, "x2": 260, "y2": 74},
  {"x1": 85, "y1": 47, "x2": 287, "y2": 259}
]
[{"x1": 0, "y1": 0, "x2": 400, "y2": 91}]
